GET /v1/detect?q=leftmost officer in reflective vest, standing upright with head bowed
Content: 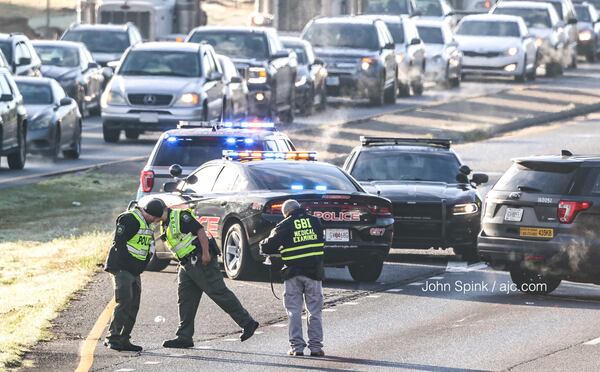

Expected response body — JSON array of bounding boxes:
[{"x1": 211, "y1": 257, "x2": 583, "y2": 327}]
[{"x1": 104, "y1": 199, "x2": 165, "y2": 351}]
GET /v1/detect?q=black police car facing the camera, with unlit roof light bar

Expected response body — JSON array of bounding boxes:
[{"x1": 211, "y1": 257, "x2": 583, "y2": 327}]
[{"x1": 343, "y1": 137, "x2": 488, "y2": 260}]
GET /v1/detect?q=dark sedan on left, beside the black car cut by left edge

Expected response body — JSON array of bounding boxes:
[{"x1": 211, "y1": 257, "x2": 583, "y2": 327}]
[{"x1": 15, "y1": 77, "x2": 82, "y2": 159}]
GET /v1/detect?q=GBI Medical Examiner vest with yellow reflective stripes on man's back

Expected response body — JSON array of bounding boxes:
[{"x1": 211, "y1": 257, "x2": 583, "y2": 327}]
[{"x1": 279, "y1": 217, "x2": 325, "y2": 262}]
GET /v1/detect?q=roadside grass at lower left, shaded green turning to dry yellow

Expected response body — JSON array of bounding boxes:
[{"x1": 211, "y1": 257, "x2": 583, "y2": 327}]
[{"x1": 0, "y1": 172, "x2": 137, "y2": 370}]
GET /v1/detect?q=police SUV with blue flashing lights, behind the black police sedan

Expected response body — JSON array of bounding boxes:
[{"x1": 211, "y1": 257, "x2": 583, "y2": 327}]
[{"x1": 137, "y1": 122, "x2": 296, "y2": 199}]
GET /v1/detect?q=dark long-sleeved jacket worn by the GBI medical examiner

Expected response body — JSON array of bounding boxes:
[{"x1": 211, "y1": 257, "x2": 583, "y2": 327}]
[{"x1": 260, "y1": 209, "x2": 325, "y2": 280}]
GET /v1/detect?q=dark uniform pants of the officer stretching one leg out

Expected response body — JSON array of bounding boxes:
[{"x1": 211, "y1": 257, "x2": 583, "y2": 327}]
[{"x1": 177, "y1": 257, "x2": 254, "y2": 341}]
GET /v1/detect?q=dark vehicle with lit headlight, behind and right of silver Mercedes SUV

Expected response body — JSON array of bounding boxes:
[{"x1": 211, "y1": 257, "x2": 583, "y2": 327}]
[{"x1": 185, "y1": 26, "x2": 296, "y2": 123}]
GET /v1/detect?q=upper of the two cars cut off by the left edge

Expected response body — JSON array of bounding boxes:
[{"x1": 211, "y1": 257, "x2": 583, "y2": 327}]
[{"x1": 0, "y1": 32, "x2": 42, "y2": 76}]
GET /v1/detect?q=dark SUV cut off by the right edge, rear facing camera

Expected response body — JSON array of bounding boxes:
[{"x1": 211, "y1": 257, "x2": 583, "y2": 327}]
[{"x1": 478, "y1": 151, "x2": 600, "y2": 293}]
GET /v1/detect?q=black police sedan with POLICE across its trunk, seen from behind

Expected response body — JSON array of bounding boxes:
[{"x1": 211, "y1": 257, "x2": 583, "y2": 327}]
[{"x1": 139, "y1": 151, "x2": 394, "y2": 281}]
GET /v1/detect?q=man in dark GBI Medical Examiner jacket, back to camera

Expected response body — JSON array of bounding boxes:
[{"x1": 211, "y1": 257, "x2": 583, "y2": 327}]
[{"x1": 260, "y1": 199, "x2": 325, "y2": 357}]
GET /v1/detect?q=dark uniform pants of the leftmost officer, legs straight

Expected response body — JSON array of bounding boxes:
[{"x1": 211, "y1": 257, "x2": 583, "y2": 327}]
[{"x1": 106, "y1": 270, "x2": 142, "y2": 344}]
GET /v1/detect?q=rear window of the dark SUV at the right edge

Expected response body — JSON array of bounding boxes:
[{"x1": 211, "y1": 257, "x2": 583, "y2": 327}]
[{"x1": 494, "y1": 163, "x2": 577, "y2": 194}]
